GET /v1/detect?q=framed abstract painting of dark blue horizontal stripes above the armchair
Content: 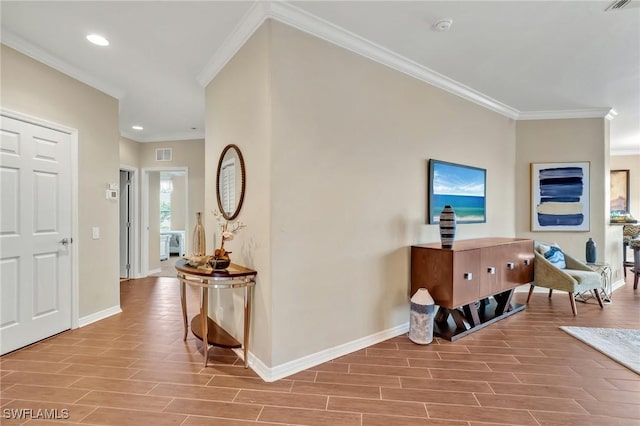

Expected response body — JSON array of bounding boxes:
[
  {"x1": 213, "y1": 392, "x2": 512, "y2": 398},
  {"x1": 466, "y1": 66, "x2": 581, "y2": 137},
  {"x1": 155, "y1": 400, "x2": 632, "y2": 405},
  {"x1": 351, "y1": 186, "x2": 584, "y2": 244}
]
[{"x1": 531, "y1": 162, "x2": 590, "y2": 231}]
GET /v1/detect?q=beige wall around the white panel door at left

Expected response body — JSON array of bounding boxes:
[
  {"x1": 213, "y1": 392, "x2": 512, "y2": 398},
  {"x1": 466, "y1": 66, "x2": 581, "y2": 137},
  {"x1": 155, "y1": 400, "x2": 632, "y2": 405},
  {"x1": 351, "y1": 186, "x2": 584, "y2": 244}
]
[{"x1": 0, "y1": 45, "x2": 120, "y2": 318}]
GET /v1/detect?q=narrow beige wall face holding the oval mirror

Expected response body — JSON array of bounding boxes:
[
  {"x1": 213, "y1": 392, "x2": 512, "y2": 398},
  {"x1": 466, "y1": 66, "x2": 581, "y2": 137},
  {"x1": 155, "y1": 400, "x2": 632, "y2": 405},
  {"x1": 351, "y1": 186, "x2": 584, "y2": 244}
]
[{"x1": 204, "y1": 25, "x2": 272, "y2": 366}]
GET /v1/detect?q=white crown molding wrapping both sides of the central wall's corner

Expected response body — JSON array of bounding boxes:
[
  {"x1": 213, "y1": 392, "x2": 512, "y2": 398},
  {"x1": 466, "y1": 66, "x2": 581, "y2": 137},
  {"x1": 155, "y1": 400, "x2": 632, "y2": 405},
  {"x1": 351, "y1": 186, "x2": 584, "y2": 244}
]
[{"x1": 198, "y1": 1, "x2": 520, "y2": 119}]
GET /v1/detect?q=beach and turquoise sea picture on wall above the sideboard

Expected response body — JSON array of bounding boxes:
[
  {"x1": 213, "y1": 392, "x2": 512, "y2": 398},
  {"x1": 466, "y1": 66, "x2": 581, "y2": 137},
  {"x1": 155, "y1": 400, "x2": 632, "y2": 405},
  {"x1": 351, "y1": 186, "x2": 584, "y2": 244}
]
[{"x1": 428, "y1": 159, "x2": 487, "y2": 224}]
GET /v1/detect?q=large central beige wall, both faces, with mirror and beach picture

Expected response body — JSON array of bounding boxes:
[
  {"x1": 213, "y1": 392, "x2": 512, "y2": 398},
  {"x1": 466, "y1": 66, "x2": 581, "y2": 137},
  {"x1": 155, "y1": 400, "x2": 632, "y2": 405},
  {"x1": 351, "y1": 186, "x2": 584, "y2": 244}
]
[{"x1": 206, "y1": 21, "x2": 515, "y2": 366}]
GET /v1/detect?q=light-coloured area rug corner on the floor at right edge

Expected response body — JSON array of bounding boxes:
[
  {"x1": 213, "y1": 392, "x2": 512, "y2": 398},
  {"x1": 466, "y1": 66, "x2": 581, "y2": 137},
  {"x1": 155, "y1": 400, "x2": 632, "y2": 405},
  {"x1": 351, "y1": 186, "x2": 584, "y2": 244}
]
[{"x1": 560, "y1": 326, "x2": 640, "y2": 374}]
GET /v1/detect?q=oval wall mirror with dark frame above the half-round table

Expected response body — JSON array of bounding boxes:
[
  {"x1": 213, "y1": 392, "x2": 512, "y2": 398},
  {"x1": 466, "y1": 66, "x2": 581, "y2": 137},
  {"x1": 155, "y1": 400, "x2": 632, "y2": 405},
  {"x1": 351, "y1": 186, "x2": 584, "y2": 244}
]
[{"x1": 216, "y1": 145, "x2": 245, "y2": 220}]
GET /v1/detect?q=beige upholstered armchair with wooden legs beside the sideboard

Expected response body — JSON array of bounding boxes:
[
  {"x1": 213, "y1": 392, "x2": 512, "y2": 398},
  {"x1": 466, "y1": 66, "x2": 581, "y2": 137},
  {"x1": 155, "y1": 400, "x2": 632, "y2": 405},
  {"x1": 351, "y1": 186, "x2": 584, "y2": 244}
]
[{"x1": 527, "y1": 243, "x2": 604, "y2": 315}]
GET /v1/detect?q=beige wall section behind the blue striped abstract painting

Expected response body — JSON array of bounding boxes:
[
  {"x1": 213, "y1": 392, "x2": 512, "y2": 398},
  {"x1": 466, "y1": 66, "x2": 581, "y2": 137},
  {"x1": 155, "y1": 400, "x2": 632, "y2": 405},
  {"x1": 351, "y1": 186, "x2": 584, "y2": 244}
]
[{"x1": 516, "y1": 118, "x2": 622, "y2": 282}]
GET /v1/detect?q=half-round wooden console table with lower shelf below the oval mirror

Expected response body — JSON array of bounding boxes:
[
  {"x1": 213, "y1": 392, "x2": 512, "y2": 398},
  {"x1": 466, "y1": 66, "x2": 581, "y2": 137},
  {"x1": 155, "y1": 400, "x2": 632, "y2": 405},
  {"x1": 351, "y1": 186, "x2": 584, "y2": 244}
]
[{"x1": 176, "y1": 259, "x2": 258, "y2": 368}]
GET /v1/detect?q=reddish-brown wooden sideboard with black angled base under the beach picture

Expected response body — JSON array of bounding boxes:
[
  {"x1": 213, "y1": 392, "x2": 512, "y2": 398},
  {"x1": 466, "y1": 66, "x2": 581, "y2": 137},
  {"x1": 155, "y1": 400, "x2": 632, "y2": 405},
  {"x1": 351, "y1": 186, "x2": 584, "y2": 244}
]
[{"x1": 411, "y1": 238, "x2": 534, "y2": 341}]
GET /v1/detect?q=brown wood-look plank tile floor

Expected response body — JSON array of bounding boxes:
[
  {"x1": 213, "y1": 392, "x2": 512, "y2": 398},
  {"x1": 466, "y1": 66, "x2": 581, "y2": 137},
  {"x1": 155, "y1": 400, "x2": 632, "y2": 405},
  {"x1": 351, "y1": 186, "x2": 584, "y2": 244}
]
[{"x1": 0, "y1": 274, "x2": 640, "y2": 426}]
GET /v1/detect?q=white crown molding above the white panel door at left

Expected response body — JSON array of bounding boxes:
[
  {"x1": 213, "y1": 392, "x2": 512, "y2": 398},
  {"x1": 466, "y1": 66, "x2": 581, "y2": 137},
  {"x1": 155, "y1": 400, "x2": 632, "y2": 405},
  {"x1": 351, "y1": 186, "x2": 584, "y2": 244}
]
[{"x1": 2, "y1": 29, "x2": 125, "y2": 99}]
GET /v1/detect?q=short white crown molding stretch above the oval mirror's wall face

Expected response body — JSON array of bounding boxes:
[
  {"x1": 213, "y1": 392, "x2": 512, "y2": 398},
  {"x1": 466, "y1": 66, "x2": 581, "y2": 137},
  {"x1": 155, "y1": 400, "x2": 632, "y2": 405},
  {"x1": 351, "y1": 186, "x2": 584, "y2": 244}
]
[{"x1": 197, "y1": 1, "x2": 270, "y2": 87}]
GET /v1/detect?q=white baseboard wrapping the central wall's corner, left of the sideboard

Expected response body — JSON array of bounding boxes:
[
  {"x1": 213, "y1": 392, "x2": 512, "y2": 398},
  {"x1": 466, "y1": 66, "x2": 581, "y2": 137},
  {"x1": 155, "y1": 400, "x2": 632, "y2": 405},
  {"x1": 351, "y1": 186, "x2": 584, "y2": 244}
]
[{"x1": 234, "y1": 322, "x2": 409, "y2": 382}]
